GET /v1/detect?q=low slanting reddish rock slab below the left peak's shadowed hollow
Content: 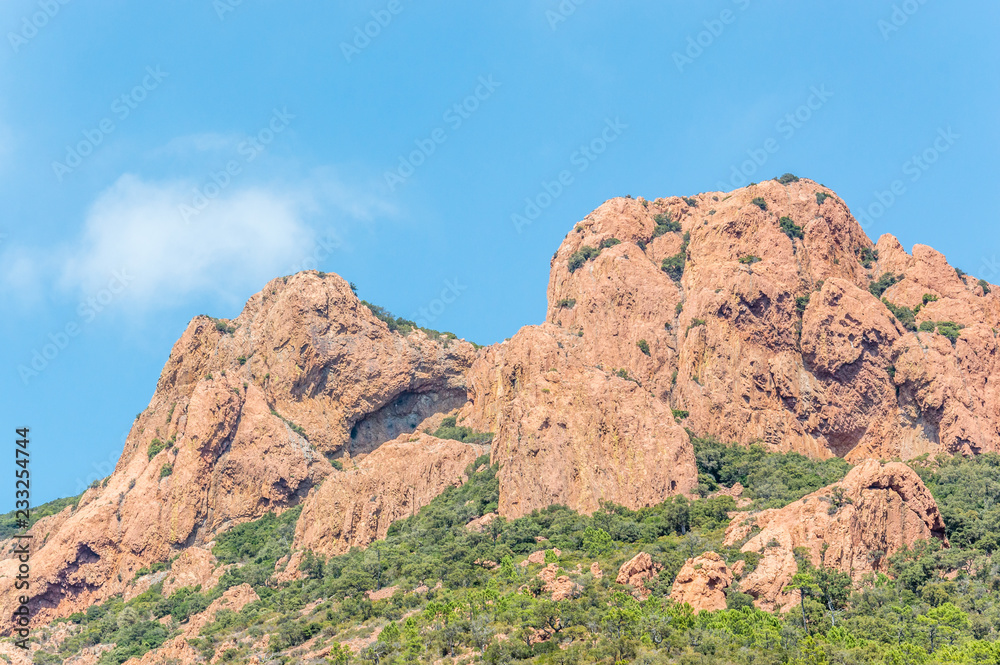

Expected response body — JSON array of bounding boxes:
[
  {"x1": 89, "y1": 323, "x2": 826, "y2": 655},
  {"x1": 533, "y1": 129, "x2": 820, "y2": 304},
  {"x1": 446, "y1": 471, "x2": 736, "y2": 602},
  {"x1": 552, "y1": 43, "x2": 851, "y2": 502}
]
[{"x1": 294, "y1": 432, "x2": 489, "y2": 556}]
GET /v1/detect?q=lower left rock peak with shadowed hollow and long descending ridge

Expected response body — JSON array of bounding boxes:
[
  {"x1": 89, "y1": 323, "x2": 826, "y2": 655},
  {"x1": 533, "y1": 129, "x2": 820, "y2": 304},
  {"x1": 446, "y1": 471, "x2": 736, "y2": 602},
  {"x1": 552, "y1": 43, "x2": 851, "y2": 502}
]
[{"x1": 0, "y1": 272, "x2": 475, "y2": 627}]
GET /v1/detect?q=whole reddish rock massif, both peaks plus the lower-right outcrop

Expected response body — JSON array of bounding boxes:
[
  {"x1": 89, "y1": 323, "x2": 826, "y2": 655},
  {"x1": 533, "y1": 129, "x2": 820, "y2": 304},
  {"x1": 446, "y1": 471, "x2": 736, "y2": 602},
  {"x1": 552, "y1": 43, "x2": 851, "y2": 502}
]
[{"x1": 0, "y1": 179, "x2": 1000, "y2": 644}]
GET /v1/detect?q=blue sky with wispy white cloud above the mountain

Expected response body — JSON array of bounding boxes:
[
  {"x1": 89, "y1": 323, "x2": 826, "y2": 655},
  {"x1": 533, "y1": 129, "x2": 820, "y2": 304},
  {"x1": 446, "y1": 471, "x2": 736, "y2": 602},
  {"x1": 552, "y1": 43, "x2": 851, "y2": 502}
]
[{"x1": 0, "y1": 0, "x2": 1000, "y2": 505}]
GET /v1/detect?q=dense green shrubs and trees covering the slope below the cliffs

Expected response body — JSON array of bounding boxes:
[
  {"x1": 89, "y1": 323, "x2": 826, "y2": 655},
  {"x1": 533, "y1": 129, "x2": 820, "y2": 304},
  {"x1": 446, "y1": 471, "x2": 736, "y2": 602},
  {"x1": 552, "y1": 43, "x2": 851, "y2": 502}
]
[{"x1": 21, "y1": 439, "x2": 1000, "y2": 665}]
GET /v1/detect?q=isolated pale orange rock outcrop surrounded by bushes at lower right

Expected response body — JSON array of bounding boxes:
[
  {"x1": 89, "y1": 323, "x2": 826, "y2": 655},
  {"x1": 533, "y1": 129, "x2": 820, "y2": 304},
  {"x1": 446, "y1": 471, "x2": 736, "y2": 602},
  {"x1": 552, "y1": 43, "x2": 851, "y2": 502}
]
[{"x1": 724, "y1": 460, "x2": 947, "y2": 609}]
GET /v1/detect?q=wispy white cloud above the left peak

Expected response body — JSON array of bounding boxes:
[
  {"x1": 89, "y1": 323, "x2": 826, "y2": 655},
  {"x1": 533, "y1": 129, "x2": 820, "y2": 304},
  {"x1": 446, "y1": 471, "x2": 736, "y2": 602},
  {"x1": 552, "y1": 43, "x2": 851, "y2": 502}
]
[{"x1": 41, "y1": 171, "x2": 391, "y2": 309}]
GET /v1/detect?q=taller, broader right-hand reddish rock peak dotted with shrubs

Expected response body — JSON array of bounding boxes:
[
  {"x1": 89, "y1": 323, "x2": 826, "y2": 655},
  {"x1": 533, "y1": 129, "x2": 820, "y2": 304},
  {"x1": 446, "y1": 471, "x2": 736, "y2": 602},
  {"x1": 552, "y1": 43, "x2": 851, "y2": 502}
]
[{"x1": 528, "y1": 179, "x2": 1000, "y2": 460}]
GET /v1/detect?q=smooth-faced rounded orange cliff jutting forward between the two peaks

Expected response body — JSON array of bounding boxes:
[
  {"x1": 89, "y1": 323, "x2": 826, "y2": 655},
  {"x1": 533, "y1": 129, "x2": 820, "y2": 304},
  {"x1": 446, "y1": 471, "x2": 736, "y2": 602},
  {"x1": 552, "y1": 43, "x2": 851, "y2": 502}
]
[{"x1": 460, "y1": 324, "x2": 697, "y2": 518}]
